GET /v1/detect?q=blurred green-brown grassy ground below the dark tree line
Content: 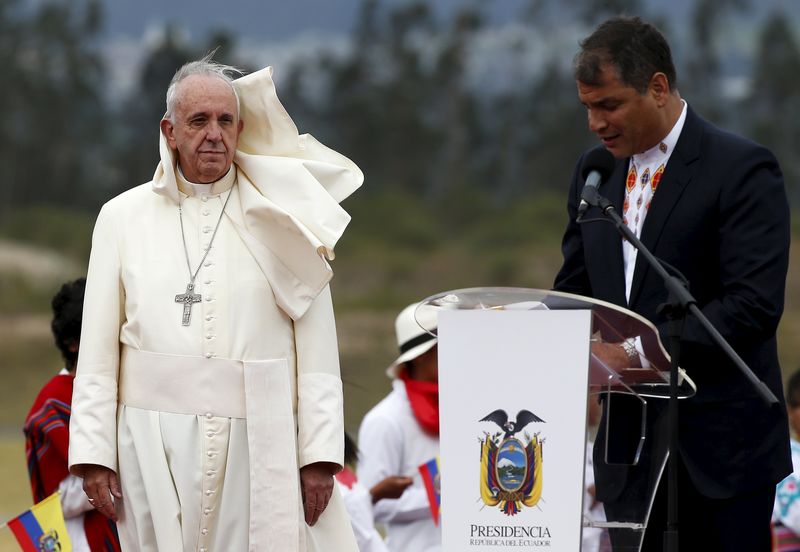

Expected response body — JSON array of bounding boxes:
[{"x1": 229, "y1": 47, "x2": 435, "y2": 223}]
[{"x1": 0, "y1": 199, "x2": 800, "y2": 528}]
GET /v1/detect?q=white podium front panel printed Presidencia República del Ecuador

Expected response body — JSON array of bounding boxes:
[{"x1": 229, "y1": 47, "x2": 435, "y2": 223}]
[{"x1": 438, "y1": 310, "x2": 592, "y2": 552}]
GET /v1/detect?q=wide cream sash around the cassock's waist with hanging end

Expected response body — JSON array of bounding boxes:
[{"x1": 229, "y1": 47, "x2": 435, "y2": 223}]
[{"x1": 119, "y1": 347, "x2": 305, "y2": 552}]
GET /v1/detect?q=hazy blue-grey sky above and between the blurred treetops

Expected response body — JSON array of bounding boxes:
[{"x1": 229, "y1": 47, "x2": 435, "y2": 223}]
[{"x1": 97, "y1": 0, "x2": 800, "y2": 98}]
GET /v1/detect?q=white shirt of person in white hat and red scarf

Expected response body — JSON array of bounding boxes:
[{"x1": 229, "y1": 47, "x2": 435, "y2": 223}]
[{"x1": 358, "y1": 380, "x2": 442, "y2": 552}]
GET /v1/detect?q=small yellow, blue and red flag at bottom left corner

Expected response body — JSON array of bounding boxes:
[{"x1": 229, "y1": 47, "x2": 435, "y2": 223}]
[{"x1": 6, "y1": 492, "x2": 72, "y2": 552}]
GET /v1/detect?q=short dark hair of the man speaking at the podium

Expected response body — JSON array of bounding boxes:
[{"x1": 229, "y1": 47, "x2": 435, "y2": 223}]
[{"x1": 573, "y1": 17, "x2": 678, "y2": 94}]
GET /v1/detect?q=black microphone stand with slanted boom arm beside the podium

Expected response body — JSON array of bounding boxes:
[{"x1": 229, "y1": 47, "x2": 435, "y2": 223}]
[{"x1": 576, "y1": 186, "x2": 778, "y2": 552}]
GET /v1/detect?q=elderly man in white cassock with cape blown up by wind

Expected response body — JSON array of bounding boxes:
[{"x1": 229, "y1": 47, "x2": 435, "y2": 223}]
[{"x1": 70, "y1": 56, "x2": 363, "y2": 552}]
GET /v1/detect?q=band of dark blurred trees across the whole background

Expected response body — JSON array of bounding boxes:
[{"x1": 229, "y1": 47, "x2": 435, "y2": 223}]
[{"x1": 0, "y1": 0, "x2": 800, "y2": 220}]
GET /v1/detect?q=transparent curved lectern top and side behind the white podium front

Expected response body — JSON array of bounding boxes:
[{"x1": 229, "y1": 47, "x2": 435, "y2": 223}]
[{"x1": 416, "y1": 287, "x2": 696, "y2": 552}]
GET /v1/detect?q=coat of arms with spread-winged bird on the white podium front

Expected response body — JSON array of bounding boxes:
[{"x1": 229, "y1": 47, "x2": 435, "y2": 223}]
[{"x1": 480, "y1": 410, "x2": 544, "y2": 516}]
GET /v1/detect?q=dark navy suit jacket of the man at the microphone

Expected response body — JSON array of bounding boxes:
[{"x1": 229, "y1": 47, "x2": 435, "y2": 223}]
[{"x1": 554, "y1": 107, "x2": 792, "y2": 499}]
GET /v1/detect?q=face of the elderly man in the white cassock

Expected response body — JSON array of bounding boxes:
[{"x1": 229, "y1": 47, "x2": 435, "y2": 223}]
[{"x1": 161, "y1": 75, "x2": 243, "y2": 184}]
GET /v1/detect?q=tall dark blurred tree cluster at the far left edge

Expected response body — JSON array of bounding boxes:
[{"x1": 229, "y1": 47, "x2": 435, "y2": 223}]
[{"x1": 0, "y1": 0, "x2": 107, "y2": 219}]
